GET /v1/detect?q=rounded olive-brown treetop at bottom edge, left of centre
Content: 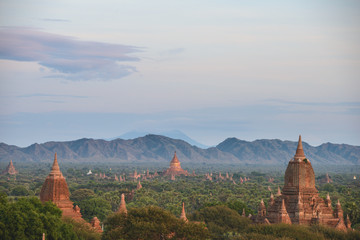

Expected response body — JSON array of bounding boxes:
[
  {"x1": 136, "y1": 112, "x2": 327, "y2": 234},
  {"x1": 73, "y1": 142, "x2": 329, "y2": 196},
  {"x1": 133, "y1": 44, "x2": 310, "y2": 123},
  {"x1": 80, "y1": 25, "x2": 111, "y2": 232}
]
[{"x1": 103, "y1": 206, "x2": 209, "y2": 240}]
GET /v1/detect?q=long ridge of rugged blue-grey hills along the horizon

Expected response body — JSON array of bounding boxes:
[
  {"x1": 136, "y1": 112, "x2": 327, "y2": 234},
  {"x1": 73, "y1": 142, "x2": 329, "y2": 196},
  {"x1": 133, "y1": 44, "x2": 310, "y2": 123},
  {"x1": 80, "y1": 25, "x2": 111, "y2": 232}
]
[{"x1": 0, "y1": 134, "x2": 360, "y2": 165}]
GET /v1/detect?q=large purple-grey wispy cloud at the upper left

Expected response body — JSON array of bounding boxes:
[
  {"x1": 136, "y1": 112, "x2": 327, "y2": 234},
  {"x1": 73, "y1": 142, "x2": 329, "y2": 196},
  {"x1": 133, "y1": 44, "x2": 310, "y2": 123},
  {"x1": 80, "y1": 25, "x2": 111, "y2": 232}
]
[{"x1": 0, "y1": 28, "x2": 140, "y2": 81}]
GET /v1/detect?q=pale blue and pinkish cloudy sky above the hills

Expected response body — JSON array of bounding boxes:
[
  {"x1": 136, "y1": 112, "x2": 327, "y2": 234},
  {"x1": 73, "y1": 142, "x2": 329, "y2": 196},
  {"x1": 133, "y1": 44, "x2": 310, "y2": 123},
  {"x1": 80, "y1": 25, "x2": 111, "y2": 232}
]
[{"x1": 0, "y1": 0, "x2": 360, "y2": 147}]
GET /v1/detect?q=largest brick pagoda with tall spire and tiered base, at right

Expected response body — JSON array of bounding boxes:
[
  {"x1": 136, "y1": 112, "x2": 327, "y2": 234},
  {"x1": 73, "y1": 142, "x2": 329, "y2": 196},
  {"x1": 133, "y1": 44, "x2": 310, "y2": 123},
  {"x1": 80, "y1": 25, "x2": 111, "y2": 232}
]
[{"x1": 253, "y1": 136, "x2": 351, "y2": 230}]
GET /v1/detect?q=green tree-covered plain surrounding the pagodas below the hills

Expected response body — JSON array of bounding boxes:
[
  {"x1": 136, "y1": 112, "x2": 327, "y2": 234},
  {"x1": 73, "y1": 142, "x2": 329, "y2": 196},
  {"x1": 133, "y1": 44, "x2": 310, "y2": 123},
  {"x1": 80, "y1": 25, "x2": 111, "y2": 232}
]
[{"x1": 0, "y1": 162, "x2": 360, "y2": 239}]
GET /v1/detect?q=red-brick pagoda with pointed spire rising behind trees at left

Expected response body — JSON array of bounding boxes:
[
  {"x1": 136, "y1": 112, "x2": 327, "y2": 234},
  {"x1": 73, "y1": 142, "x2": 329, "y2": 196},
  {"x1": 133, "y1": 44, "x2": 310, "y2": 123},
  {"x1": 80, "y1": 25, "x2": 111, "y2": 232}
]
[{"x1": 40, "y1": 153, "x2": 84, "y2": 221}]
